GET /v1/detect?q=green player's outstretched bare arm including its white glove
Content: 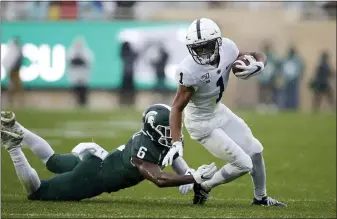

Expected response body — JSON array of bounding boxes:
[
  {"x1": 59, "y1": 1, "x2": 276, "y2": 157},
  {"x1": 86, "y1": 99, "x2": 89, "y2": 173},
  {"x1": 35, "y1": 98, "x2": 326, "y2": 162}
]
[{"x1": 132, "y1": 157, "x2": 216, "y2": 187}]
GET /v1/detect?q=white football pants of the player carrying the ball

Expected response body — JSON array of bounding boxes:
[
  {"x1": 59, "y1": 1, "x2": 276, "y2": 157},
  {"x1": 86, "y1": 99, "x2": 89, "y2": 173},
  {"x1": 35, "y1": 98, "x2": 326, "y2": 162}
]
[{"x1": 185, "y1": 104, "x2": 263, "y2": 169}]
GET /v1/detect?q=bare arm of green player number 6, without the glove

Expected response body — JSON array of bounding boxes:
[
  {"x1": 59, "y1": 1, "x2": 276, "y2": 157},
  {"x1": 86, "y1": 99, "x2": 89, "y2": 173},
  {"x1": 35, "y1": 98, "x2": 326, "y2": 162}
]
[{"x1": 132, "y1": 157, "x2": 195, "y2": 187}]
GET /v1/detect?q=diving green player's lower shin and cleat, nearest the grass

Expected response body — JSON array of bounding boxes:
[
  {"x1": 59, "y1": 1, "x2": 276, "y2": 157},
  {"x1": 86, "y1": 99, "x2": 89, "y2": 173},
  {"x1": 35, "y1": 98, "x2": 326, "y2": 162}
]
[{"x1": 1, "y1": 123, "x2": 41, "y2": 195}]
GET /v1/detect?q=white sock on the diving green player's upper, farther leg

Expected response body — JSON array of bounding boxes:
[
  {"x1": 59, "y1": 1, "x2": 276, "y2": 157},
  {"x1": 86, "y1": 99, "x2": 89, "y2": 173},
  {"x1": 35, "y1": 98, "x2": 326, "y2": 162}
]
[{"x1": 19, "y1": 124, "x2": 55, "y2": 164}]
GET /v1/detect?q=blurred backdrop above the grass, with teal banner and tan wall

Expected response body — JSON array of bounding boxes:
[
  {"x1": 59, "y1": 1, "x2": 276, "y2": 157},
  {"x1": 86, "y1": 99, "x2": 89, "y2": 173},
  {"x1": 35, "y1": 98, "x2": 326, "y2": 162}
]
[{"x1": 1, "y1": 1, "x2": 336, "y2": 111}]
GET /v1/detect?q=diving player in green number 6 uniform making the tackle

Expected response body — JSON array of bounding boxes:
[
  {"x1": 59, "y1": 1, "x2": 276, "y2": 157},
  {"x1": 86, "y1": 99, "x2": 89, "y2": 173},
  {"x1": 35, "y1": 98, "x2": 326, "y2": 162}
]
[{"x1": 1, "y1": 104, "x2": 216, "y2": 201}]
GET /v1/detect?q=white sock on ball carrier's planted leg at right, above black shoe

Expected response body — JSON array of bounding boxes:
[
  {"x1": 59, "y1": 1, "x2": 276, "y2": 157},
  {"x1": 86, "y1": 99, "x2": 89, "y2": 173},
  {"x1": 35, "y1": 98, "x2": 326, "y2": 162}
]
[{"x1": 250, "y1": 153, "x2": 267, "y2": 200}]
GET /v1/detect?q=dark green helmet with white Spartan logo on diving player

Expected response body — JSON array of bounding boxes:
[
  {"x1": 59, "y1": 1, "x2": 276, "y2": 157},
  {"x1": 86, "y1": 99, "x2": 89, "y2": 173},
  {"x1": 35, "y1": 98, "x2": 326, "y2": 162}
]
[{"x1": 142, "y1": 104, "x2": 183, "y2": 147}]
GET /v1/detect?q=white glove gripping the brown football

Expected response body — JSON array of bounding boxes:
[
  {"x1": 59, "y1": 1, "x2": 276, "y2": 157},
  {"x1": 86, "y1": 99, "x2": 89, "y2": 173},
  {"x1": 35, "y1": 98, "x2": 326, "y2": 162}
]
[{"x1": 235, "y1": 55, "x2": 264, "y2": 79}]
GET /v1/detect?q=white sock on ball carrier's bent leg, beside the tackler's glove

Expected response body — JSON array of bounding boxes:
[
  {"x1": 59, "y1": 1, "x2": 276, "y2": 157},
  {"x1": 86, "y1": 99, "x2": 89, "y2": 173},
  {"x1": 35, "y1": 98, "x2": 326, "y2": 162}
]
[{"x1": 201, "y1": 163, "x2": 248, "y2": 190}]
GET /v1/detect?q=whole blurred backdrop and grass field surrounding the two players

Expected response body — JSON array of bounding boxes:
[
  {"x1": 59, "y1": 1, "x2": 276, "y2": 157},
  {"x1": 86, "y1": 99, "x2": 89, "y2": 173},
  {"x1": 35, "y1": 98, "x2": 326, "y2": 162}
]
[{"x1": 0, "y1": 1, "x2": 336, "y2": 218}]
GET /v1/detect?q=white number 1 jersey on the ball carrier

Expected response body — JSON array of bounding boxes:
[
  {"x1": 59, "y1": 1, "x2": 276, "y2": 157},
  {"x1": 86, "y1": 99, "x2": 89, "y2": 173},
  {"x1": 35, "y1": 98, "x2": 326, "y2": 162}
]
[{"x1": 175, "y1": 38, "x2": 239, "y2": 120}]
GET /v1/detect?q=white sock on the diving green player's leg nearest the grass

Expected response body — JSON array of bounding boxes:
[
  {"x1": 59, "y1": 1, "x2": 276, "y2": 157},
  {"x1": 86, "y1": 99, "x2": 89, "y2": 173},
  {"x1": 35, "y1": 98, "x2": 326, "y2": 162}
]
[{"x1": 8, "y1": 147, "x2": 41, "y2": 195}]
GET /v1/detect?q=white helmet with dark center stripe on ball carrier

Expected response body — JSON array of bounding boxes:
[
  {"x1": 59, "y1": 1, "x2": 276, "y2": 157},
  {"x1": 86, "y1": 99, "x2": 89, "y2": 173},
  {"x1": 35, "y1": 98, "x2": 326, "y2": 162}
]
[{"x1": 186, "y1": 18, "x2": 222, "y2": 65}]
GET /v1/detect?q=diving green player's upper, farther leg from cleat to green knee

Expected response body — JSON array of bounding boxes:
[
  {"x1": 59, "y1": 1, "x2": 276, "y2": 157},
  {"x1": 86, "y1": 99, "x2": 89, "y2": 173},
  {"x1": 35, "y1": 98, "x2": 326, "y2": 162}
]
[{"x1": 1, "y1": 111, "x2": 79, "y2": 173}]
